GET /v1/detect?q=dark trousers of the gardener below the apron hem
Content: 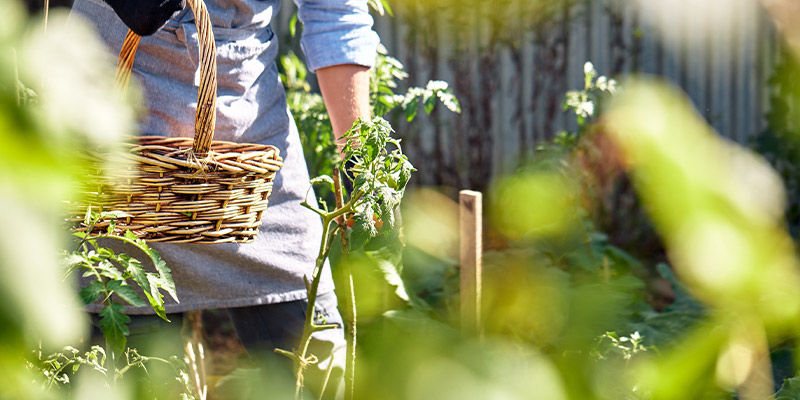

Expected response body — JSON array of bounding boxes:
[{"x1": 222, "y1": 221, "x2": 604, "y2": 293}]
[{"x1": 93, "y1": 292, "x2": 345, "y2": 399}]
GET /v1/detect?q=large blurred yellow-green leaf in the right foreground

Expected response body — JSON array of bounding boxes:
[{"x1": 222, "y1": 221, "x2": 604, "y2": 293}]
[{"x1": 605, "y1": 81, "x2": 800, "y2": 399}]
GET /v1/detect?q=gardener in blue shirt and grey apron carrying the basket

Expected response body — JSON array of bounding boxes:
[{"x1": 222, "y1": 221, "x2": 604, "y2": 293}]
[{"x1": 72, "y1": 0, "x2": 379, "y2": 396}]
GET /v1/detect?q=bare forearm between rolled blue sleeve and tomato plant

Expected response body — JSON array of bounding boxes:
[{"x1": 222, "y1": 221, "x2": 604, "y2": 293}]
[{"x1": 317, "y1": 64, "x2": 371, "y2": 149}]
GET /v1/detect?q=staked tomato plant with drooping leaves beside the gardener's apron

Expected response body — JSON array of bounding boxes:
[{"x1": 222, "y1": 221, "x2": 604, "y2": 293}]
[{"x1": 276, "y1": 117, "x2": 414, "y2": 398}]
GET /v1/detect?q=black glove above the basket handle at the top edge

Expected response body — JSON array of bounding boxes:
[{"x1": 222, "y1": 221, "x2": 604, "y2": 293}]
[{"x1": 103, "y1": 0, "x2": 186, "y2": 36}]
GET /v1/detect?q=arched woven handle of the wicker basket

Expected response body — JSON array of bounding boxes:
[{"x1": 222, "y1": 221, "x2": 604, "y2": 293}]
[{"x1": 117, "y1": 0, "x2": 217, "y2": 155}]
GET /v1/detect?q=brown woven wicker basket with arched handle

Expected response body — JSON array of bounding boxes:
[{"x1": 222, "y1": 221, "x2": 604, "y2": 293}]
[{"x1": 72, "y1": 0, "x2": 283, "y2": 243}]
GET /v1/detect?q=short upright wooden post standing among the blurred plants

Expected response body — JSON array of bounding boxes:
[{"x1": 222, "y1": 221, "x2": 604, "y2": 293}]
[{"x1": 458, "y1": 190, "x2": 483, "y2": 333}]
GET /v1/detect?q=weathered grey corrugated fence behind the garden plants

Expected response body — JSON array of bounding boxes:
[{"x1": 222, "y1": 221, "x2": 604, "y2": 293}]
[{"x1": 278, "y1": 0, "x2": 776, "y2": 189}]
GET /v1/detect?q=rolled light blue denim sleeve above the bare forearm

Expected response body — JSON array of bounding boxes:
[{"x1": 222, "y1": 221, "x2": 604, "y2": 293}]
[{"x1": 294, "y1": 0, "x2": 380, "y2": 71}]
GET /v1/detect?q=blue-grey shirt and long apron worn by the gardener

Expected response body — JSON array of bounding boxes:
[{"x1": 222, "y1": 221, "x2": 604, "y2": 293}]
[{"x1": 73, "y1": 0, "x2": 379, "y2": 314}]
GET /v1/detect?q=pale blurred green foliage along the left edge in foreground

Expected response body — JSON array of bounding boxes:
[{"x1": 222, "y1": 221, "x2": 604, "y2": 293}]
[{"x1": 0, "y1": 0, "x2": 133, "y2": 398}]
